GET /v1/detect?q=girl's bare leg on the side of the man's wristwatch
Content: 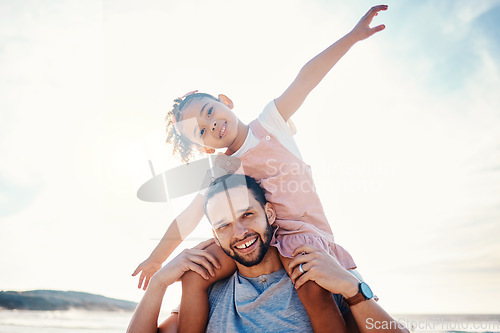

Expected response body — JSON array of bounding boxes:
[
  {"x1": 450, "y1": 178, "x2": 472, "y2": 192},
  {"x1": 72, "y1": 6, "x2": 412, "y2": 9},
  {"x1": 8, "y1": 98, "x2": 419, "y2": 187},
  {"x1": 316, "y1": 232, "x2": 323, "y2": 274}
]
[{"x1": 280, "y1": 254, "x2": 347, "y2": 333}]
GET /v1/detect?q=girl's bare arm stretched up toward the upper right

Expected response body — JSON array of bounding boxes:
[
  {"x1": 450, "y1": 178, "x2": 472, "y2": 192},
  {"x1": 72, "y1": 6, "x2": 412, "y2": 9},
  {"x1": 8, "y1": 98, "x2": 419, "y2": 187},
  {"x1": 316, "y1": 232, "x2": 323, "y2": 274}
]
[{"x1": 274, "y1": 5, "x2": 387, "y2": 121}]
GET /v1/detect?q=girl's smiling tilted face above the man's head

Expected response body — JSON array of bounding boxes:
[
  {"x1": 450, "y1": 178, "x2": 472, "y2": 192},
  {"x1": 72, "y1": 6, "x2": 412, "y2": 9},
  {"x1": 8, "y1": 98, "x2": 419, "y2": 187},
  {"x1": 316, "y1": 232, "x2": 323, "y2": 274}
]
[{"x1": 178, "y1": 97, "x2": 239, "y2": 149}]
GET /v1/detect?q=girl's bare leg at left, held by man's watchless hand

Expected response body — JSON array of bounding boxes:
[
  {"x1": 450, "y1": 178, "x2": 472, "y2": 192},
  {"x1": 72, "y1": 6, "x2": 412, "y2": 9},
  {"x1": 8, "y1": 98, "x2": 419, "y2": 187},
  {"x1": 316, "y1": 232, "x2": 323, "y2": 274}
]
[{"x1": 178, "y1": 244, "x2": 236, "y2": 332}]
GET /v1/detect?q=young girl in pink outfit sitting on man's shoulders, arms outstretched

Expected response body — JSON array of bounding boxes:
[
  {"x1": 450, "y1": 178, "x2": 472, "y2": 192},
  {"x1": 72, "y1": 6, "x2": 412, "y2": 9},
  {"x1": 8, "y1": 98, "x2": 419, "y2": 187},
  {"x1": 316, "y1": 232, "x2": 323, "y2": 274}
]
[{"x1": 133, "y1": 5, "x2": 387, "y2": 332}]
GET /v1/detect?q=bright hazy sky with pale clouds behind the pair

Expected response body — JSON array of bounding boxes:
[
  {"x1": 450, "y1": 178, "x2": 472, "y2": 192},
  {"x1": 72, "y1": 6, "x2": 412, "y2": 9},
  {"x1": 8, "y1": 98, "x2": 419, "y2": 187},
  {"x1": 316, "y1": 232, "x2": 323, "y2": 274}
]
[{"x1": 0, "y1": 0, "x2": 500, "y2": 313}]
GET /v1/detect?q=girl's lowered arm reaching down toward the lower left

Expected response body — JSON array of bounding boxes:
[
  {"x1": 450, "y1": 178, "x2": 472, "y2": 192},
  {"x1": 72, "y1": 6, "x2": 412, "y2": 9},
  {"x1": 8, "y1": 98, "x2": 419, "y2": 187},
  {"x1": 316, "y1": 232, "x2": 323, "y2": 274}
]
[{"x1": 132, "y1": 194, "x2": 204, "y2": 290}]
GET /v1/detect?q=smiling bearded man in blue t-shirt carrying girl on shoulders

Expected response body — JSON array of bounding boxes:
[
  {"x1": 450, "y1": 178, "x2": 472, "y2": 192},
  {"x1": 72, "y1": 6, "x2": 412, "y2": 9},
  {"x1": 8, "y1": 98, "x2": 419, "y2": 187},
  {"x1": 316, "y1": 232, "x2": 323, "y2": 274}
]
[{"x1": 128, "y1": 175, "x2": 407, "y2": 332}]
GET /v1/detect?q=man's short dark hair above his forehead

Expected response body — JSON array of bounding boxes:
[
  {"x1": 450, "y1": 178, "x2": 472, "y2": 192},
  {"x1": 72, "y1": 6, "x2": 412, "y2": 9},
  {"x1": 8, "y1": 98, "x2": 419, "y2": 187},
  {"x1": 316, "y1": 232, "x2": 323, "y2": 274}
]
[{"x1": 203, "y1": 174, "x2": 267, "y2": 217}]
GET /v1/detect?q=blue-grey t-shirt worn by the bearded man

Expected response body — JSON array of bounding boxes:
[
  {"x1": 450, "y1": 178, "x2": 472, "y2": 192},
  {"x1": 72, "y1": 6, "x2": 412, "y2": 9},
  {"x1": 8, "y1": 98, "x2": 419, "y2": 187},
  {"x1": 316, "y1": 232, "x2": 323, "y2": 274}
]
[{"x1": 207, "y1": 269, "x2": 350, "y2": 333}]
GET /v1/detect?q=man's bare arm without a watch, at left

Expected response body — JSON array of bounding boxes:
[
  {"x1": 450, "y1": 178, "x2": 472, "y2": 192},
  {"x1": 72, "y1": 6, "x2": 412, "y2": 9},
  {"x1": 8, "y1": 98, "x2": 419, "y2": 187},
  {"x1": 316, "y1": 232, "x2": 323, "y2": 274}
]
[{"x1": 127, "y1": 239, "x2": 220, "y2": 333}]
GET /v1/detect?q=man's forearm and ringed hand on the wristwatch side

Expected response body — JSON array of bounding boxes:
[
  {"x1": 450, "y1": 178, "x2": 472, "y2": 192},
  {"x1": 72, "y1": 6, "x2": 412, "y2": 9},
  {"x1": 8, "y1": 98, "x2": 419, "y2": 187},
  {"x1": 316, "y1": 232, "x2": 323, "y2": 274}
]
[{"x1": 289, "y1": 245, "x2": 409, "y2": 333}]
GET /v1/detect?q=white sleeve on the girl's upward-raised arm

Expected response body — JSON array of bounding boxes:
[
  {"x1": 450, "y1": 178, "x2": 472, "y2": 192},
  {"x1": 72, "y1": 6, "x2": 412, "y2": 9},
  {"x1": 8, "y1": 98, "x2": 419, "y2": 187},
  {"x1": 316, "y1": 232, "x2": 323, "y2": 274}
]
[{"x1": 257, "y1": 100, "x2": 302, "y2": 159}]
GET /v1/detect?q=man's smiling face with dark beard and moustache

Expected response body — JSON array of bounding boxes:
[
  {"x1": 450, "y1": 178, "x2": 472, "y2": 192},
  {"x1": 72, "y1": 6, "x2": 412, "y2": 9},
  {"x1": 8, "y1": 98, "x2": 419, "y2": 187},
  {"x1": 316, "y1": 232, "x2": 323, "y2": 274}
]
[{"x1": 207, "y1": 186, "x2": 274, "y2": 267}]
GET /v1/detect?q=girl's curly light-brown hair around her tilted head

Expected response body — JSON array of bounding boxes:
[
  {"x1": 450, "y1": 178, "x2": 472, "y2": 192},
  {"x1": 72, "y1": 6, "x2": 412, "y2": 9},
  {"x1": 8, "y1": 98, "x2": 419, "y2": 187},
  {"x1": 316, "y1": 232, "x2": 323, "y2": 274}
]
[{"x1": 165, "y1": 93, "x2": 217, "y2": 163}]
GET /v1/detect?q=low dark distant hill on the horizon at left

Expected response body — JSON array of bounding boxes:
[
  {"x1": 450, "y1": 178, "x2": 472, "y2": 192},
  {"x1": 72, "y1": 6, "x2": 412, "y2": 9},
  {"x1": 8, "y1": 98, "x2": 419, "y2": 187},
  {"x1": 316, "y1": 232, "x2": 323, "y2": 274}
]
[{"x1": 0, "y1": 290, "x2": 137, "y2": 311}]
